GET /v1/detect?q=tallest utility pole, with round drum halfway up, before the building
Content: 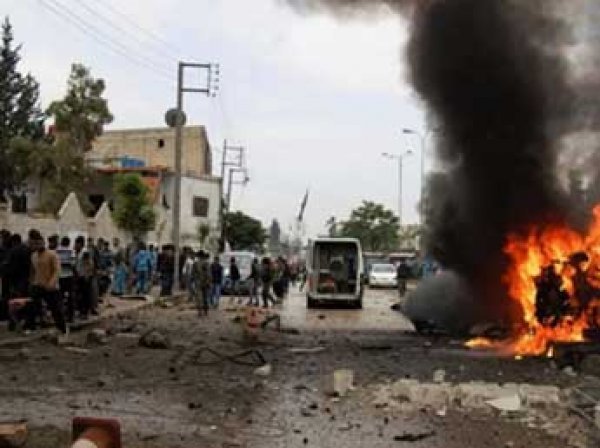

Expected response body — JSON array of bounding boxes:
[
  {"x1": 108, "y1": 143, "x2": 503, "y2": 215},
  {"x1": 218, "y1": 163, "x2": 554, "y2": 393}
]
[{"x1": 165, "y1": 62, "x2": 219, "y2": 285}]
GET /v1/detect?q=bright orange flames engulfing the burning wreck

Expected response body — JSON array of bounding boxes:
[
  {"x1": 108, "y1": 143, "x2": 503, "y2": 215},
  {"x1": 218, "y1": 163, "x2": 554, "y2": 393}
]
[{"x1": 467, "y1": 205, "x2": 600, "y2": 356}]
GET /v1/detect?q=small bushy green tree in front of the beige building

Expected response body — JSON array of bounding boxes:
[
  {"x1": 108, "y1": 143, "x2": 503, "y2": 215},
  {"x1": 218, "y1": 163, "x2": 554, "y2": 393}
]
[{"x1": 113, "y1": 173, "x2": 156, "y2": 236}]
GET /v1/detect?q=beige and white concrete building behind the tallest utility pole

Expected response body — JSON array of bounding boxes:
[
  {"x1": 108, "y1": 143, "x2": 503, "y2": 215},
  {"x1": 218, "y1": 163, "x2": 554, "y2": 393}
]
[{"x1": 86, "y1": 126, "x2": 222, "y2": 247}]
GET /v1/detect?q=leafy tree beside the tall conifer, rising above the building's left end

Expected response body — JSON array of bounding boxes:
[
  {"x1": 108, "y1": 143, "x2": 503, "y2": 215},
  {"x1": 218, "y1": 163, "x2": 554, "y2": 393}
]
[{"x1": 47, "y1": 64, "x2": 113, "y2": 154}]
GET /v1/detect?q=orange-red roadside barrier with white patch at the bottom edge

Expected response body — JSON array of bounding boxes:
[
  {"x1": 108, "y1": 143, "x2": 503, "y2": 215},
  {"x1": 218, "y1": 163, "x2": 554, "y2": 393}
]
[{"x1": 71, "y1": 417, "x2": 122, "y2": 448}]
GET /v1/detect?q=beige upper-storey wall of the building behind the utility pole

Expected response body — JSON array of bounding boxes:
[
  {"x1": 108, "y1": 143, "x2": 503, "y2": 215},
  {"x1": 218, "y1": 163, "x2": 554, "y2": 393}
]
[{"x1": 86, "y1": 126, "x2": 212, "y2": 176}]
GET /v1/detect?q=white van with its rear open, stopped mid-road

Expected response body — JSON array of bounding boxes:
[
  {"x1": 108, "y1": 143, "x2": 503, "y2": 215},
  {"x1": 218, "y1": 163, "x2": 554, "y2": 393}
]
[{"x1": 306, "y1": 238, "x2": 363, "y2": 308}]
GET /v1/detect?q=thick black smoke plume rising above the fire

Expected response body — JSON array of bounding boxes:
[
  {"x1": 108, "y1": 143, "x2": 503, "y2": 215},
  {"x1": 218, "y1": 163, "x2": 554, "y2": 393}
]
[{"x1": 287, "y1": 0, "x2": 588, "y2": 320}]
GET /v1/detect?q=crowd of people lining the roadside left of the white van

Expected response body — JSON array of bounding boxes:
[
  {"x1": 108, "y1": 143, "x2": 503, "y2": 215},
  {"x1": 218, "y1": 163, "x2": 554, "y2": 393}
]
[{"x1": 0, "y1": 230, "x2": 299, "y2": 333}]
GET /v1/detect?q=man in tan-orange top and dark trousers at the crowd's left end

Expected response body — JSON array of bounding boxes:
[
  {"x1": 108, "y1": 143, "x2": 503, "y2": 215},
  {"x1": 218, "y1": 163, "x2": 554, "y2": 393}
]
[{"x1": 27, "y1": 231, "x2": 67, "y2": 334}]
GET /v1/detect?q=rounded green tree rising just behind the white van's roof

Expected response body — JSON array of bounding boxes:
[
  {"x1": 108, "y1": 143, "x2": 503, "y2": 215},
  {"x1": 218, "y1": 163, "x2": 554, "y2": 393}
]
[{"x1": 339, "y1": 201, "x2": 399, "y2": 252}]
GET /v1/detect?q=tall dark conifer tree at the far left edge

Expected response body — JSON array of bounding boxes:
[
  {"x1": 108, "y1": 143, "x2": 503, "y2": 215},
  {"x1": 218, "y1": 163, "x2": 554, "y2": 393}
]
[{"x1": 0, "y1": 18, "x2": 44, "y2": 202}]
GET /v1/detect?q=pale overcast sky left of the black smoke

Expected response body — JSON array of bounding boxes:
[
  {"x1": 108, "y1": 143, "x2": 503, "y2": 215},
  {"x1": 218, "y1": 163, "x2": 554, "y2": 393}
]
[{"x1": 0, "y1": 0, "x2": 431, "y2": 236}]
